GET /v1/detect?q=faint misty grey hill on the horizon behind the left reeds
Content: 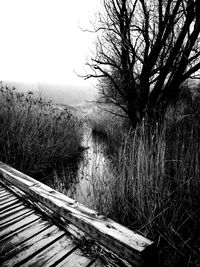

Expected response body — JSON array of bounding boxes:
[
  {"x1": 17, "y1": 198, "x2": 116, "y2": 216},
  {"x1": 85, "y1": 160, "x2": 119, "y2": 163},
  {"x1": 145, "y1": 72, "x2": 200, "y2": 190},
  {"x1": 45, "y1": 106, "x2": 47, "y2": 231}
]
[{"x1": 3, "y1": 81, "x2": 97, "y2": 105}]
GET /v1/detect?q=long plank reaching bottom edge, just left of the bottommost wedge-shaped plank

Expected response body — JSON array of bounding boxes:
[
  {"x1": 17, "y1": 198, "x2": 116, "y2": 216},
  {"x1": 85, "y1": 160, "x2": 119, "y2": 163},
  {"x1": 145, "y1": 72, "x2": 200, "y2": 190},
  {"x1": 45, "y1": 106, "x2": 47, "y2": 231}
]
[{"x1": 20, "y1": 235, "x2": 77, "y2": 267}]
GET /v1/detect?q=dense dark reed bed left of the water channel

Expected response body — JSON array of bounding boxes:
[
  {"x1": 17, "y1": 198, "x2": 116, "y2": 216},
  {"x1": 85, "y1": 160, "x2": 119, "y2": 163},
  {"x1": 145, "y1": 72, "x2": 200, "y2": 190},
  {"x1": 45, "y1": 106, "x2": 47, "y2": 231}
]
[{"x1": 0, "y1": 85, "x2": 81, "y2": 178}]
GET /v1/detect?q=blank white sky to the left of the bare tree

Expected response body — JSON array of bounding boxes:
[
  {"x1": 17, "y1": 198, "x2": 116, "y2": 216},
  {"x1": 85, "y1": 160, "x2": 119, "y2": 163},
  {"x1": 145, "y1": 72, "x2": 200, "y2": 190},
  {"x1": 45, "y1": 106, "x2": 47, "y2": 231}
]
[{"x1": 0, "y1": 0, "x2": 100, "y2": 85}]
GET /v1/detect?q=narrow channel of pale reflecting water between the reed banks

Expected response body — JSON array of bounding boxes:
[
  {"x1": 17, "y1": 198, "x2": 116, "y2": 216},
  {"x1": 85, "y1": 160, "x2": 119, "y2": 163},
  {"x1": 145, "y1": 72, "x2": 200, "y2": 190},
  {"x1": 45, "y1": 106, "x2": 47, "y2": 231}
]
[{"x1": 44, "y1": 123, "x2": 112, "y2": 209}]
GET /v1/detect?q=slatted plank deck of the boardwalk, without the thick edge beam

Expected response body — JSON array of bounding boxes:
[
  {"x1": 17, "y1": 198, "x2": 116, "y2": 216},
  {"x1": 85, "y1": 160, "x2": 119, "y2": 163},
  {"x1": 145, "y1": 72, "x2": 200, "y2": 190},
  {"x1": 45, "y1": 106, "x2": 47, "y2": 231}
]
[{"x1": 0, "y1": 185, "x2": 104, "y2": 267}]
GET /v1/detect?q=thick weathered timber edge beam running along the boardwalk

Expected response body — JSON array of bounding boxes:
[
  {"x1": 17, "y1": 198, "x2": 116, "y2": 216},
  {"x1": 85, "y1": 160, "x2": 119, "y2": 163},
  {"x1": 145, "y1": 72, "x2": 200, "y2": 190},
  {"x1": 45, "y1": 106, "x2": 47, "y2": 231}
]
[{"x1": 0, "y1": 162, "x2": 156, "y2": 266}]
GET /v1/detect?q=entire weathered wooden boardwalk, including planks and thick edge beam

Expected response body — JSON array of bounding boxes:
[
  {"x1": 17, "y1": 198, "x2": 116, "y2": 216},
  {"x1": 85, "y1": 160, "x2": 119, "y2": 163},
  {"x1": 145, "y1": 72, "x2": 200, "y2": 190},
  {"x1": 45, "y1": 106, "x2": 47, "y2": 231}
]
[{"x1": 0, "y1": 163, "x2": 155, "y2": 267}]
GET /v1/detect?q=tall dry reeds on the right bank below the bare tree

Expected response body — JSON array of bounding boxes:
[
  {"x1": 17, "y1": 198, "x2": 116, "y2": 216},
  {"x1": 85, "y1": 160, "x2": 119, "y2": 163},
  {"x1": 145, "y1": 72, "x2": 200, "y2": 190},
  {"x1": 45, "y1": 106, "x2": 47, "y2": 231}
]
[{"x1": 89, "y1": 101, "x2": 200, "y2": 266}]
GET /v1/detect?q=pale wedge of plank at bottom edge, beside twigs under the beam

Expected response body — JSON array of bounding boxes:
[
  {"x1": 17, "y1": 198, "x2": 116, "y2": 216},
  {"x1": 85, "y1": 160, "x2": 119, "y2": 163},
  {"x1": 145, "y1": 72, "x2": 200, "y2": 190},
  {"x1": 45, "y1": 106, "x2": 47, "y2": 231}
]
[{"x1": 57, "y1": 249, "x2": 92, "y2": 267}]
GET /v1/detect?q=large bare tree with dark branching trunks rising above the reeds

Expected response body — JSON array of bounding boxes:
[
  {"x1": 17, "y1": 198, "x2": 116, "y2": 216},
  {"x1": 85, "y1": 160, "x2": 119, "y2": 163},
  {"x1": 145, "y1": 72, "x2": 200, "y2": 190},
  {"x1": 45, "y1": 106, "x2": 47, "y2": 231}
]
[{"x1": 85, "y1": 0, "x2": 200, "y2": 125}]
